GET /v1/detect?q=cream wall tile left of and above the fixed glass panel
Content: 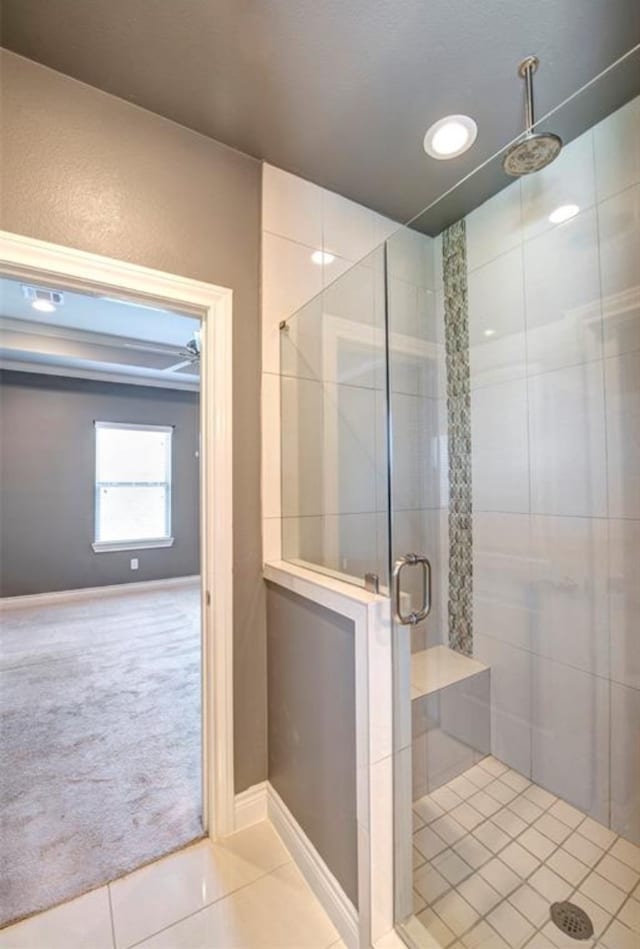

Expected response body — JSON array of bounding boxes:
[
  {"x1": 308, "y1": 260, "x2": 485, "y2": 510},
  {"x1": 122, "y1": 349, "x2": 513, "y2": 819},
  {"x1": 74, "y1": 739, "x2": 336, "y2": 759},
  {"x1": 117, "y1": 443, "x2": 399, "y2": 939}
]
[{"x1": 262, "y1": 164, "x2": 398, "y2": 560}]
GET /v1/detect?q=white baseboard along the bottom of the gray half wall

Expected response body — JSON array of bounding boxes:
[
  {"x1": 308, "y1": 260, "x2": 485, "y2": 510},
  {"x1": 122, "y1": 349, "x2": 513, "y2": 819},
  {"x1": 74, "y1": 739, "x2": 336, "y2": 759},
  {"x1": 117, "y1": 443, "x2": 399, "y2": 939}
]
[{"x1": 235, "y1": 781, "x2": 360, "y2": 949}]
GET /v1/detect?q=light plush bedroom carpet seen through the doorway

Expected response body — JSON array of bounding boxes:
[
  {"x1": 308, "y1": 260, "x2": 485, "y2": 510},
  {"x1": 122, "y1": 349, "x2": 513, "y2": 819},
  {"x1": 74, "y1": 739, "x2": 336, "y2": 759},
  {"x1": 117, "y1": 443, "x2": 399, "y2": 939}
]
[{"x1": 0, "y1": 584, "x2": 202, "y2": 925}]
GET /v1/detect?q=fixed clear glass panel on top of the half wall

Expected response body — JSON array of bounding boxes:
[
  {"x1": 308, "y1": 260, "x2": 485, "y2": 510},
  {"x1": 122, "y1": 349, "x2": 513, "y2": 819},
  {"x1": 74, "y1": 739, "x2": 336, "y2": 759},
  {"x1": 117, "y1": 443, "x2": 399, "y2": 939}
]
[{"x1": 280, "y1": 248, "x2": 388, "y2": 584}]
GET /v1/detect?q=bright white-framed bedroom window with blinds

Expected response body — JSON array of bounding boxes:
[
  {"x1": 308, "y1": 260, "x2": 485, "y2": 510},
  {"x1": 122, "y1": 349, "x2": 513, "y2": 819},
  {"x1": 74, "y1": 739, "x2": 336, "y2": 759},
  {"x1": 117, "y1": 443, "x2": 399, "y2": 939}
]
[{"x1": 93, "y1": 422, "x2": 173, "y2": 552}]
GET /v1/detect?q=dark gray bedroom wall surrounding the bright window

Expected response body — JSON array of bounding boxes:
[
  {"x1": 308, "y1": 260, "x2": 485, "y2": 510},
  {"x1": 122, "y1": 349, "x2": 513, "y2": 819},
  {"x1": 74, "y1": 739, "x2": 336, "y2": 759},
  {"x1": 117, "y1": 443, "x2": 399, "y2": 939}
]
[{"x1": 0, "y1": 372, "x2": 200, "y2": 596}]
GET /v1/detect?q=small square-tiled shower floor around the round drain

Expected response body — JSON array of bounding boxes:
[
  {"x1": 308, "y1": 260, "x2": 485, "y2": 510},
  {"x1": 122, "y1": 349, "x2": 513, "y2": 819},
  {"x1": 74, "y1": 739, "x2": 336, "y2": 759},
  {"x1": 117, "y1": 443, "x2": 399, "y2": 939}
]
[{"x1": 413, "y1": 757, "x2": 640, "y2": 949}]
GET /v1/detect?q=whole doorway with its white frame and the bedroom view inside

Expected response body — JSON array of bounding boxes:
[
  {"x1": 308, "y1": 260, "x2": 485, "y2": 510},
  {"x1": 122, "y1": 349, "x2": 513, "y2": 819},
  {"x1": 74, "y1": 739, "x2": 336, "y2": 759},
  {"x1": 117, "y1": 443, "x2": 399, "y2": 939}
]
[{"x1": 0, "y1": 235, "x2": 233, "y2": 924}]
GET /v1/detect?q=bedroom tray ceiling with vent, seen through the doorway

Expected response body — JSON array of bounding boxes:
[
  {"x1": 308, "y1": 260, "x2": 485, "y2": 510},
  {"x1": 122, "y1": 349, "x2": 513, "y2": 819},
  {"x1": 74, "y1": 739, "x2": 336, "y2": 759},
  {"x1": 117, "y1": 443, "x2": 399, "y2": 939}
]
[{"x1": 0, "y1": 277, "x2": 200, "y2": 389}]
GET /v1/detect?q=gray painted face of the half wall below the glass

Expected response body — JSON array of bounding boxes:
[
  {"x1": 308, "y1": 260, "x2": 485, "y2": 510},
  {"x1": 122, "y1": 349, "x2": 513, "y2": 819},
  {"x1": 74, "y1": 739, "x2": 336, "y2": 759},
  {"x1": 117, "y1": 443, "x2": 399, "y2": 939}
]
[{"x1": 267, "y1": 584, "x2": 358, "y2": 907}]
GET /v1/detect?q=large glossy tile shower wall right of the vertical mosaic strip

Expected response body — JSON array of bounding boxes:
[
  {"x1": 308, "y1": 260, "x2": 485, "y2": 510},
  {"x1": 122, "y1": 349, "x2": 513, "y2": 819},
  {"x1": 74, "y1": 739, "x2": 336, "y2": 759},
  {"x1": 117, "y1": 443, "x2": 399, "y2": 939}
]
[{"x1": 460, "y1": 92, "x2": 640, "y2": 841}]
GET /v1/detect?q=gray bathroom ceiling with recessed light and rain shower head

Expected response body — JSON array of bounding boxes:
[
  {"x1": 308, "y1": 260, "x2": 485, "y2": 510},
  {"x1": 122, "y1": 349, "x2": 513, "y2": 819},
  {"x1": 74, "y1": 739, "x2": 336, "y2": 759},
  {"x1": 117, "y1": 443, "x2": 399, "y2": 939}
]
[{"x1": 2, "y1": 0, "x2": 640, "y2": 231}]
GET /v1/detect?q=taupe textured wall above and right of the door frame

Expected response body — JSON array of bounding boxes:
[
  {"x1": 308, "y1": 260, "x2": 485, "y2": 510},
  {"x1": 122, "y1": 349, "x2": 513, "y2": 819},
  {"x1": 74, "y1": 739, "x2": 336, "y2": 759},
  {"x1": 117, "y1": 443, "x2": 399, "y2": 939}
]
[{"x1": 0, "y1": 51, "x2": 267, "y2": 791}]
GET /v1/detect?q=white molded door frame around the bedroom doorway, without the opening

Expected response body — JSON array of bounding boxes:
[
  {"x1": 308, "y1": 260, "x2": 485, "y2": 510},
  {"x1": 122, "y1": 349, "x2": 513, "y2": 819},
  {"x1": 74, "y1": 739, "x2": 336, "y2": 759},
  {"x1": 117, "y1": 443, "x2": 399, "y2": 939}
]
[{"x1": 0, "y1": 231, "x2": 234, "y2": 838}]
